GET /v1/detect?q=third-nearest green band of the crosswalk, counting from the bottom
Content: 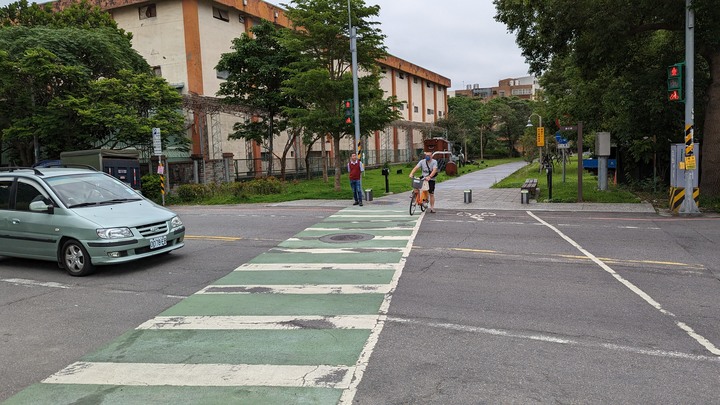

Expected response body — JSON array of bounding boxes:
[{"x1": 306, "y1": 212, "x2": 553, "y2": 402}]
[{"x1": 160, "y1": 294, "x2": 385, "y2": 316}]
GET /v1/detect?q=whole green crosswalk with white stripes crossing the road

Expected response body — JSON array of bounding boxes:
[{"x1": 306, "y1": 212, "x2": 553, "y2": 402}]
[{"x1": 5, "y1": 205, "x2": 422, "y2": 404}]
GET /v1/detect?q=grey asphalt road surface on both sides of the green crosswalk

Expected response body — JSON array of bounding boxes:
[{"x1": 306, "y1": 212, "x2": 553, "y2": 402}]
[{"x1": 0, "y1": 206, "x2": 720, "y2": 404}]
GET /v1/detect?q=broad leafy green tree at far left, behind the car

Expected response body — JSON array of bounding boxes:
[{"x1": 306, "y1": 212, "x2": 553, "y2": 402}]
[{"x1": 0, "y1": 2, "x2": 184, "y2": 165}]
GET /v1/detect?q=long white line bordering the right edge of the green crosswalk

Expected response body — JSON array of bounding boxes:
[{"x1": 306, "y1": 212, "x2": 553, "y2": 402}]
[{"x1": 339, "y1": 207, "x2": 425, "y2": 405}]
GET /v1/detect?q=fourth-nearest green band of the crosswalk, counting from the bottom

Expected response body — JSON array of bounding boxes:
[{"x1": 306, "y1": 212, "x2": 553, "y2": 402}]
[{"x1": 212, "y1": 270, "x2": 395, "y2": 285}]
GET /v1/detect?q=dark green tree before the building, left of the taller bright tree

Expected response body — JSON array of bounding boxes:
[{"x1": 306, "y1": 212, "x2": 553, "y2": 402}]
[{"x1": 216, "y1": 20, "x2": 297, "y2": 178}]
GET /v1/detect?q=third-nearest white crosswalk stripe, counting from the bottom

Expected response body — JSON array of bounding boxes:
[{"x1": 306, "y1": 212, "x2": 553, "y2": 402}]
[{"x1": 196, "y1": 284, "x2": 390, "y2": 294}]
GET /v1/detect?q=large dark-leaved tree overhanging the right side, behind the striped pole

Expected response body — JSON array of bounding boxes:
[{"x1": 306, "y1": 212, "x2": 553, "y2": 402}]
[{"x1": 494, "y1": 0, "x2": 720, "y2": 196}]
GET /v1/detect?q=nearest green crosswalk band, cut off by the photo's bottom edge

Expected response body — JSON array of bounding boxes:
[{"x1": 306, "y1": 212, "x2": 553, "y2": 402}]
[{"x1": 3, "y1": 384, "x2": 342, "y2": 405}]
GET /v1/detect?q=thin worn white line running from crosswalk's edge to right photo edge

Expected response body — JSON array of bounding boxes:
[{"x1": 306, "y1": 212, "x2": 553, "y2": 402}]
[{"x1": 387, "y1": 317, "x2": 720, "y2": 362}]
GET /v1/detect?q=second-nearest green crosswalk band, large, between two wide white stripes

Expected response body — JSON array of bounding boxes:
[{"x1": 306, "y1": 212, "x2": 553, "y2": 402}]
[{"x1": 82, "y1": 329, "x2": 370, "y2": 366}]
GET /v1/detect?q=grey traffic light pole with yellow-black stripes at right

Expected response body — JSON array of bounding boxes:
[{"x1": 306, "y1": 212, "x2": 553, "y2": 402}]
[{"x1": 679, "y1": 0, "x2": 700, "y2": 214}]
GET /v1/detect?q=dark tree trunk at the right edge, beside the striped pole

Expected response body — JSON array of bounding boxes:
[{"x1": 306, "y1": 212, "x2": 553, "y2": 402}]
[{"x1": 699, "y1": 51, "x2": 720, "y2": 197}]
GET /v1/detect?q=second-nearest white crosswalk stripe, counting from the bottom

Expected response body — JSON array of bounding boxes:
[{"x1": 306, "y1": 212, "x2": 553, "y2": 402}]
[{"x1": 137, "y1": 315, "x2": 379, "y2": 330}]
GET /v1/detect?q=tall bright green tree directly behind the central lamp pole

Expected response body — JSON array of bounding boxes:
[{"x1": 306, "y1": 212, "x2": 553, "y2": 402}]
[{"x1": 283, "y1": 0, "x2": 400, "y2": 190}]
